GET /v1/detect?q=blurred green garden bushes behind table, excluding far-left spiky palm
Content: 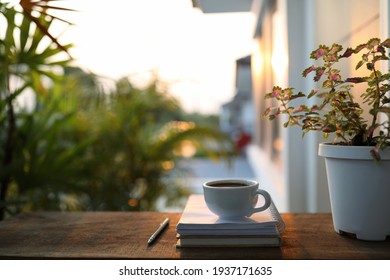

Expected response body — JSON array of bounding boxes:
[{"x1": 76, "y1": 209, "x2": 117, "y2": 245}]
[{"x1": 15, "y1": 73, "x2": 234, "y2": 210}]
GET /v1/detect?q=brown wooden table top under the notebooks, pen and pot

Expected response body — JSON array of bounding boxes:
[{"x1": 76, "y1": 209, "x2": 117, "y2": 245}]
[{"x1": 0, "y1": 212, "x2": 390, "y2": 260}]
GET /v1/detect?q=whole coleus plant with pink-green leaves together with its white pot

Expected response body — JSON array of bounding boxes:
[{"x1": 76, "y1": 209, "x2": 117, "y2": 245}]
[{"x1": 263, "y1": 38, "x2": 390, "y2": 240}]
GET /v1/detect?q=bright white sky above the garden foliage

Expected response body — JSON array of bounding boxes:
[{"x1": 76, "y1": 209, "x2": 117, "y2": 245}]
[{"x1": 58, "y1": 0, "x2": 255, "y2": 113}]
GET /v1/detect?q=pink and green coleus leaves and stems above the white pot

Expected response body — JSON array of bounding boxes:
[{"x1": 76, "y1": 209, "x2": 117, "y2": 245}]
[{"x1": 263, "y1": 38, "x2": 390, "y2": 160}]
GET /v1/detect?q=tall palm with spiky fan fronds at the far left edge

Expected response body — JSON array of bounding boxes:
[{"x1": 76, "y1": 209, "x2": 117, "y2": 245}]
[{"x1": 0, "y1": 0, "x2": 74, "y2": 220}]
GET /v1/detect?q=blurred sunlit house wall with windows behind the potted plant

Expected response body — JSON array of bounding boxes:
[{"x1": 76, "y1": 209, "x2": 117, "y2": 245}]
[{"x1": 248, "y1": 0, "x2": 384, "y2": 212}]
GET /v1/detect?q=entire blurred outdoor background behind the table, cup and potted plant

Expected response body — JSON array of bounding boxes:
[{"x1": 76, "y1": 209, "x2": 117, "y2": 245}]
[{"x1": 0, "y1": 0, "x2": 389, "y2": 219}]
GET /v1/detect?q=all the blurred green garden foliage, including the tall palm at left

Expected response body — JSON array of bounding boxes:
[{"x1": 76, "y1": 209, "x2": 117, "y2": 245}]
[{"x1": 0, "y1": 0, "x2": 235, "y2": 217}]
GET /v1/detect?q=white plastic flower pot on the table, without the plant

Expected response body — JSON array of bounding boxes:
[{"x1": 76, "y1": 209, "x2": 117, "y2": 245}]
[{"x1": 319, "y1": 144, "x2": 390, "y2": 241}]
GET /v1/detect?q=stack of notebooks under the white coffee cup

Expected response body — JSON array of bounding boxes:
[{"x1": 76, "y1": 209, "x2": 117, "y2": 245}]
[{"x1": 176, "y1": 195, "x2": 285, "y2": 247}]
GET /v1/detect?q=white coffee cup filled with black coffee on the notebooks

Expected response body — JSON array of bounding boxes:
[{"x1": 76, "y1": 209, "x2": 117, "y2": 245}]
[{"x1": 203, "y1": 179, "x2": 271, "y2": 218}]
